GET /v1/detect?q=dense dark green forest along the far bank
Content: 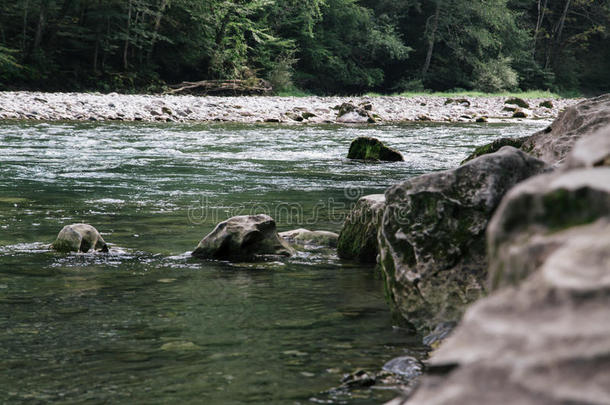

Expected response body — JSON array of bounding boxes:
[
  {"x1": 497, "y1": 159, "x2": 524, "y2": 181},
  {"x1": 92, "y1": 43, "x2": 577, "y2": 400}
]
[{"x1": 0, "y1": 0, "x2": 610, "y2": 95}]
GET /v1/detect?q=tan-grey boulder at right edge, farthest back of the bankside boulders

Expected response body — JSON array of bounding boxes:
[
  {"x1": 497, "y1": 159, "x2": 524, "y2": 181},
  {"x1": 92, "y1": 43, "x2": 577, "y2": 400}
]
[{"x1": 464, "y1": 94, "x2": 610, "y2": 165}]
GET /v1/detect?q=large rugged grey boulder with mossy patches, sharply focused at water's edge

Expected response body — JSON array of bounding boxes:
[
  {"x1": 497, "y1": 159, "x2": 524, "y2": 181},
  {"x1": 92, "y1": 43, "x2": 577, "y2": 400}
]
[{"x1": 379, "y1": 146, "x2": 545, "y2": 331}]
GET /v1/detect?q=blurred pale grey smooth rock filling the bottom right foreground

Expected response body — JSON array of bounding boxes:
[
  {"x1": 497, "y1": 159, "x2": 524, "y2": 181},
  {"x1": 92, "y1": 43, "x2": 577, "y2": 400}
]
[{"x1": 394, "y1": 211, "x2": 610, "y2": 405}]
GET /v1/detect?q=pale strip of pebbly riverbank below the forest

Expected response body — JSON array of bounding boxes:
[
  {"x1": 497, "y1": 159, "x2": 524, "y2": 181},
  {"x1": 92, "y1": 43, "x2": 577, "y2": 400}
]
[{"x1": 0, "y1": 92, "x2": 580, "y2": 124}]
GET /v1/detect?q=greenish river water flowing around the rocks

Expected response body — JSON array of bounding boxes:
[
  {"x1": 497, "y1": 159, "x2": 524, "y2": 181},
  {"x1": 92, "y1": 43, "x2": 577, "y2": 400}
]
[{"x1": 0, "y1": 122, "x2": 546, "y2": 404}]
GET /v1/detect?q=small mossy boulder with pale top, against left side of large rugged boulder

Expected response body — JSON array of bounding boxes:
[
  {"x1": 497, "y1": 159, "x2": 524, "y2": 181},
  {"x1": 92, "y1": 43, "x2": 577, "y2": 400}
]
[{"x1": 337, "y1": 194, "x2": 385, "y2": 263}]
